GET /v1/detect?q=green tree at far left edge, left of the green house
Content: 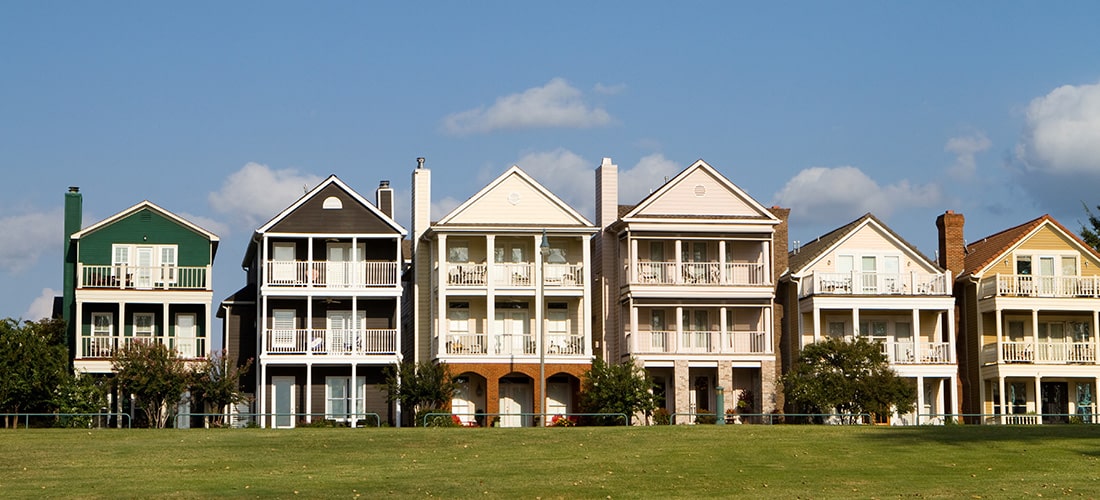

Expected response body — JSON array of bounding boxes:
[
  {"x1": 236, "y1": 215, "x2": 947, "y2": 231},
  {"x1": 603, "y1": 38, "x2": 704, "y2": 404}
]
[{"x1": 0, "y1": 318, "x2": 68, "y2": 427}]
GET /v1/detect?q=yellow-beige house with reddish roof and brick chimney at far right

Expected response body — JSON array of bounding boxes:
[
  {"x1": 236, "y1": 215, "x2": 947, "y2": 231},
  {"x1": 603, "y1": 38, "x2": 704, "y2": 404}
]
[{"x1": 937, "y1": 212, "x2": 1100, "y2": 424}]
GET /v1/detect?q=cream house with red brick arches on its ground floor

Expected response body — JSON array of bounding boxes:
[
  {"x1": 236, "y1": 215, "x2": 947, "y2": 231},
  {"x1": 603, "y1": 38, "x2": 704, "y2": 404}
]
[{"x1": 406, "y1": 163, "x2": 596, "y2": 426}]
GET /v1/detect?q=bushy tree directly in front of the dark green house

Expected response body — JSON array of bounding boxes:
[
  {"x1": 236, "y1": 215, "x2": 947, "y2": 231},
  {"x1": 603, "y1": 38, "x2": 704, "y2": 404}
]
[{"x1": 111, "y1": 341, "x2": 191, "y2": 429}]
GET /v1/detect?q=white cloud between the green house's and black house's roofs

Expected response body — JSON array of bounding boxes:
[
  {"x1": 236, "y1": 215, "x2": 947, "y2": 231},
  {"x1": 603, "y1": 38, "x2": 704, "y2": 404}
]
[{"x1": 208, "y1": 163, "x2": 323, "y2": 231}]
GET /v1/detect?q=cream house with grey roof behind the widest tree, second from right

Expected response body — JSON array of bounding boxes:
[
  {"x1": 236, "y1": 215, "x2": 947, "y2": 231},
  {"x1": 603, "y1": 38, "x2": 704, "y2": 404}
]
[{"x1": 779, "y1": 213, "x2": 959, "y2": 424}]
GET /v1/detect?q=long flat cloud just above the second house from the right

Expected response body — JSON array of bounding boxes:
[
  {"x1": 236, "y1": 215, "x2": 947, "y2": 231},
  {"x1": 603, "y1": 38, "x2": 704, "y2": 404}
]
[{"x1": 774, "y1": 166, "x2": 943, "y2": 223}]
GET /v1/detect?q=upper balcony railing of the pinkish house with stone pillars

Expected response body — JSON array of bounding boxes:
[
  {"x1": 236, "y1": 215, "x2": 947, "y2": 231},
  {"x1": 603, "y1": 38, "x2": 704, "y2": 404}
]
[{"x1": 631, "y1": 262, "x2": 770, "y2": 287}]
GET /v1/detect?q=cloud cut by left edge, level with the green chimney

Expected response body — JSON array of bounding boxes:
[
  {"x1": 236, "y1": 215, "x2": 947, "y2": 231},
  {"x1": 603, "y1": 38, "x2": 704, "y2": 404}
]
[{"x1": 0, "y1": 209, "x2": 65, "y2": 273}]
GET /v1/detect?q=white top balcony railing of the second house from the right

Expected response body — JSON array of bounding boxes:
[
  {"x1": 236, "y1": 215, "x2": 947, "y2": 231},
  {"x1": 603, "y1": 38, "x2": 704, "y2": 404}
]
[{"x1": 801, "y1": 271, "x2": 950, "y2": 297}]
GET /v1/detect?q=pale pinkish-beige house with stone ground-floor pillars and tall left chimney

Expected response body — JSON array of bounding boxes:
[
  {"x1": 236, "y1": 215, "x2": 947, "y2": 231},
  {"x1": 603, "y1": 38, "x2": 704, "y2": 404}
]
[{"x1": 593, "y1": 158, "x2": 789, "y2": 423}]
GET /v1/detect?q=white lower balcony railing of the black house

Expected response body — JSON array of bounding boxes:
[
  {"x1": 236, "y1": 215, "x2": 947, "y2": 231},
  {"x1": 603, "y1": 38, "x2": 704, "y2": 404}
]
[{"x1": 263, "y1": 329, "x2": 397, "y2": 355}]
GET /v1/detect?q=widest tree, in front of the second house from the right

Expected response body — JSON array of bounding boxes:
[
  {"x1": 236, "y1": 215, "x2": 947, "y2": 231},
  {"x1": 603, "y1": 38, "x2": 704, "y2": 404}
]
[{"x1": 782, "y1": 338, "x2": 916, "y2": 416}]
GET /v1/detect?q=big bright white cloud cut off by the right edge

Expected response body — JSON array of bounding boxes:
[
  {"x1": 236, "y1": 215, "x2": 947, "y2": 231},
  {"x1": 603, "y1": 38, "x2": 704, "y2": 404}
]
[{"x1": 1016, "y1": 84, "x2": 1100, "y2": 174}]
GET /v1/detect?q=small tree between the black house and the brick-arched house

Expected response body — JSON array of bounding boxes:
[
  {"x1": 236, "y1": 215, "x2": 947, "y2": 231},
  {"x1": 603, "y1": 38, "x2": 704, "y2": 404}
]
[{"x1": 386, "y1": 362, "x2": 459, "y2": 425}]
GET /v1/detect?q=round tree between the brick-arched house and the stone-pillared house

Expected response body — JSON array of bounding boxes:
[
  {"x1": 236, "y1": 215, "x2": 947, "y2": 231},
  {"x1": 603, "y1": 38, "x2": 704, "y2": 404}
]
[{"x1": 580, "y1": 358, "x2": 657, "y2": 425}]
